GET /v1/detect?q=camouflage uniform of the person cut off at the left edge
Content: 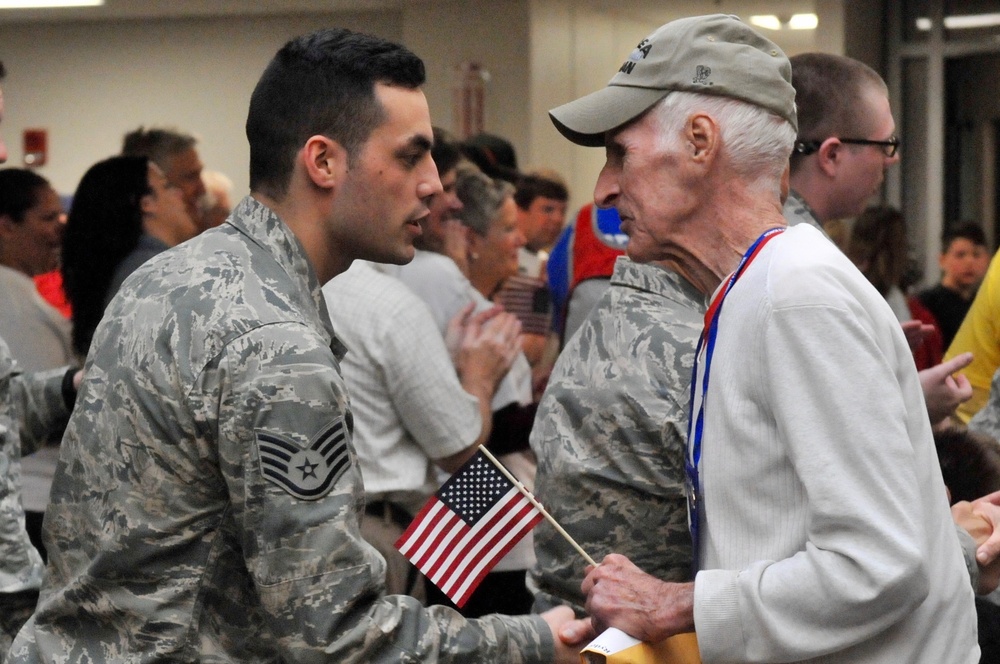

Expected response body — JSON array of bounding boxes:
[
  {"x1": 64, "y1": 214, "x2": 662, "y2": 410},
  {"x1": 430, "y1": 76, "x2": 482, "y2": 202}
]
[{"x1": 0, "y1": 339, "x2": 69, "y2": 660}]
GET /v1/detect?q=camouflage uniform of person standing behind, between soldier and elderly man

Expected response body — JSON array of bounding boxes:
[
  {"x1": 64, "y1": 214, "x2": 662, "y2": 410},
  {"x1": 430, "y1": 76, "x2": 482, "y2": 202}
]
[{"x1": 528, "y1": 257, "x2": 705, "y2": 614}]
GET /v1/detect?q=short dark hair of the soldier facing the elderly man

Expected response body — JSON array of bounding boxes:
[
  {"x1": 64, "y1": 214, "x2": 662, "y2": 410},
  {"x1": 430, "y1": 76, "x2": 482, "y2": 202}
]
[{"x1": 246, "y1": 28, "x2": 425, "y2": 200}]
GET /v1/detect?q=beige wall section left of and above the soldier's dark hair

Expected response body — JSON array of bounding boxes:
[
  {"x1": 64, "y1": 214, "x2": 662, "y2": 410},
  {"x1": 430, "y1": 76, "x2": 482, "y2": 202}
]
[{"x1": 0, "y1": 13, "x2": 402, "y2": 196}]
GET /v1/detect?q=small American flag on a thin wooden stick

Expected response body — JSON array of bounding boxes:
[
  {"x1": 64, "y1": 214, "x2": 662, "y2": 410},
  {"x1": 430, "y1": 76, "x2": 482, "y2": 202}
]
[{"x1": 396, "y1": 452, "x2": 542, "y2": 607}]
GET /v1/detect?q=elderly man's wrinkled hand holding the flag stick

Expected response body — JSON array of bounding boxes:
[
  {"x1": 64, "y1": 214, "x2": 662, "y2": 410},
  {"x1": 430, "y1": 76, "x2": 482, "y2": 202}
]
[{"x1": 581, "y1": 553, "x2": 694, "y2": 643}]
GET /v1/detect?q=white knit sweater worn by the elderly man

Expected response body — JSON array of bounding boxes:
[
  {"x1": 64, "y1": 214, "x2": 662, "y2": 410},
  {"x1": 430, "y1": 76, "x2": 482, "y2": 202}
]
[{"x1": 695, "y1": 225, "x2": 979, "y2": 664}]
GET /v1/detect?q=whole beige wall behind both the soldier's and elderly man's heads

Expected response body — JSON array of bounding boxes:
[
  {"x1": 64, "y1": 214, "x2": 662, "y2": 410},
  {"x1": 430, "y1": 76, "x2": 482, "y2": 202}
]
[{"x1": 0, "y1": 0, "x2": 878, "y2": 210}]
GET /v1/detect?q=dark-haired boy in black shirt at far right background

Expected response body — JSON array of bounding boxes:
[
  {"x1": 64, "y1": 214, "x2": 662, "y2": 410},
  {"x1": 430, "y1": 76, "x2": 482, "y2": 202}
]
[{"x1": 917, "y1": 223, "x2": 990, "y2": 348}]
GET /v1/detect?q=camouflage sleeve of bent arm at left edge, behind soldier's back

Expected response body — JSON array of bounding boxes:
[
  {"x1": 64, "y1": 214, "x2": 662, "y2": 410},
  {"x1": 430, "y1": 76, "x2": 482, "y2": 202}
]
[{"x1": 10, "y1": 367, "x2": 70, "y2": 455}]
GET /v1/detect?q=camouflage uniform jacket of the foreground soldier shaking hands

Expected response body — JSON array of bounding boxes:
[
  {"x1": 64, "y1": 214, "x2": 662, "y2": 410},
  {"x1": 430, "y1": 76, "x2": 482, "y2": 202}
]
[{"x1": 11, "y1": 198, "x2": 553, "y2": 663}]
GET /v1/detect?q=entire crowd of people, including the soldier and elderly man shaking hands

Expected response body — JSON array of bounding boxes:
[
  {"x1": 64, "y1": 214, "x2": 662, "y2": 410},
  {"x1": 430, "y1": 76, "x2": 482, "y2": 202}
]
[{"x1": 0, "y1": 15, "x2": 1000, "y2": 664}]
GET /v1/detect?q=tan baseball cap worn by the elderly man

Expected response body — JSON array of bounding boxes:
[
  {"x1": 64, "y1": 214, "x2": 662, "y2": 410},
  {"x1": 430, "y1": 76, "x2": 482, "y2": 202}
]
[{"x1": 549, "y1": 14, "x2": 798, "y2": 147}]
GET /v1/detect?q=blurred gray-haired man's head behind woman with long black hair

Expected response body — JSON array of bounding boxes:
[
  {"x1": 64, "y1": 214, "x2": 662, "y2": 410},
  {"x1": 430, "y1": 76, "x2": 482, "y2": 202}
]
[{"x1": 122, "y1": 127, "x2": 206, "y2": 232}]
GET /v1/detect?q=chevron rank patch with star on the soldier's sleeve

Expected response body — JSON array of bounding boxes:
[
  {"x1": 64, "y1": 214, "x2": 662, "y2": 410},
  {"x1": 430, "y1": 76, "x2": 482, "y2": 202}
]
[{"x1": 257, "y1": 417, "x2": 351, "y2": 500}]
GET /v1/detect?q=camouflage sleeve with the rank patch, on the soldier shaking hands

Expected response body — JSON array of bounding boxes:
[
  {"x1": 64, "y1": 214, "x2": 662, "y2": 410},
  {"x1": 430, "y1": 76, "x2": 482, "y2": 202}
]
[{"x1": 216, "y1": 324, "x2": 553, "y2": 663}]
